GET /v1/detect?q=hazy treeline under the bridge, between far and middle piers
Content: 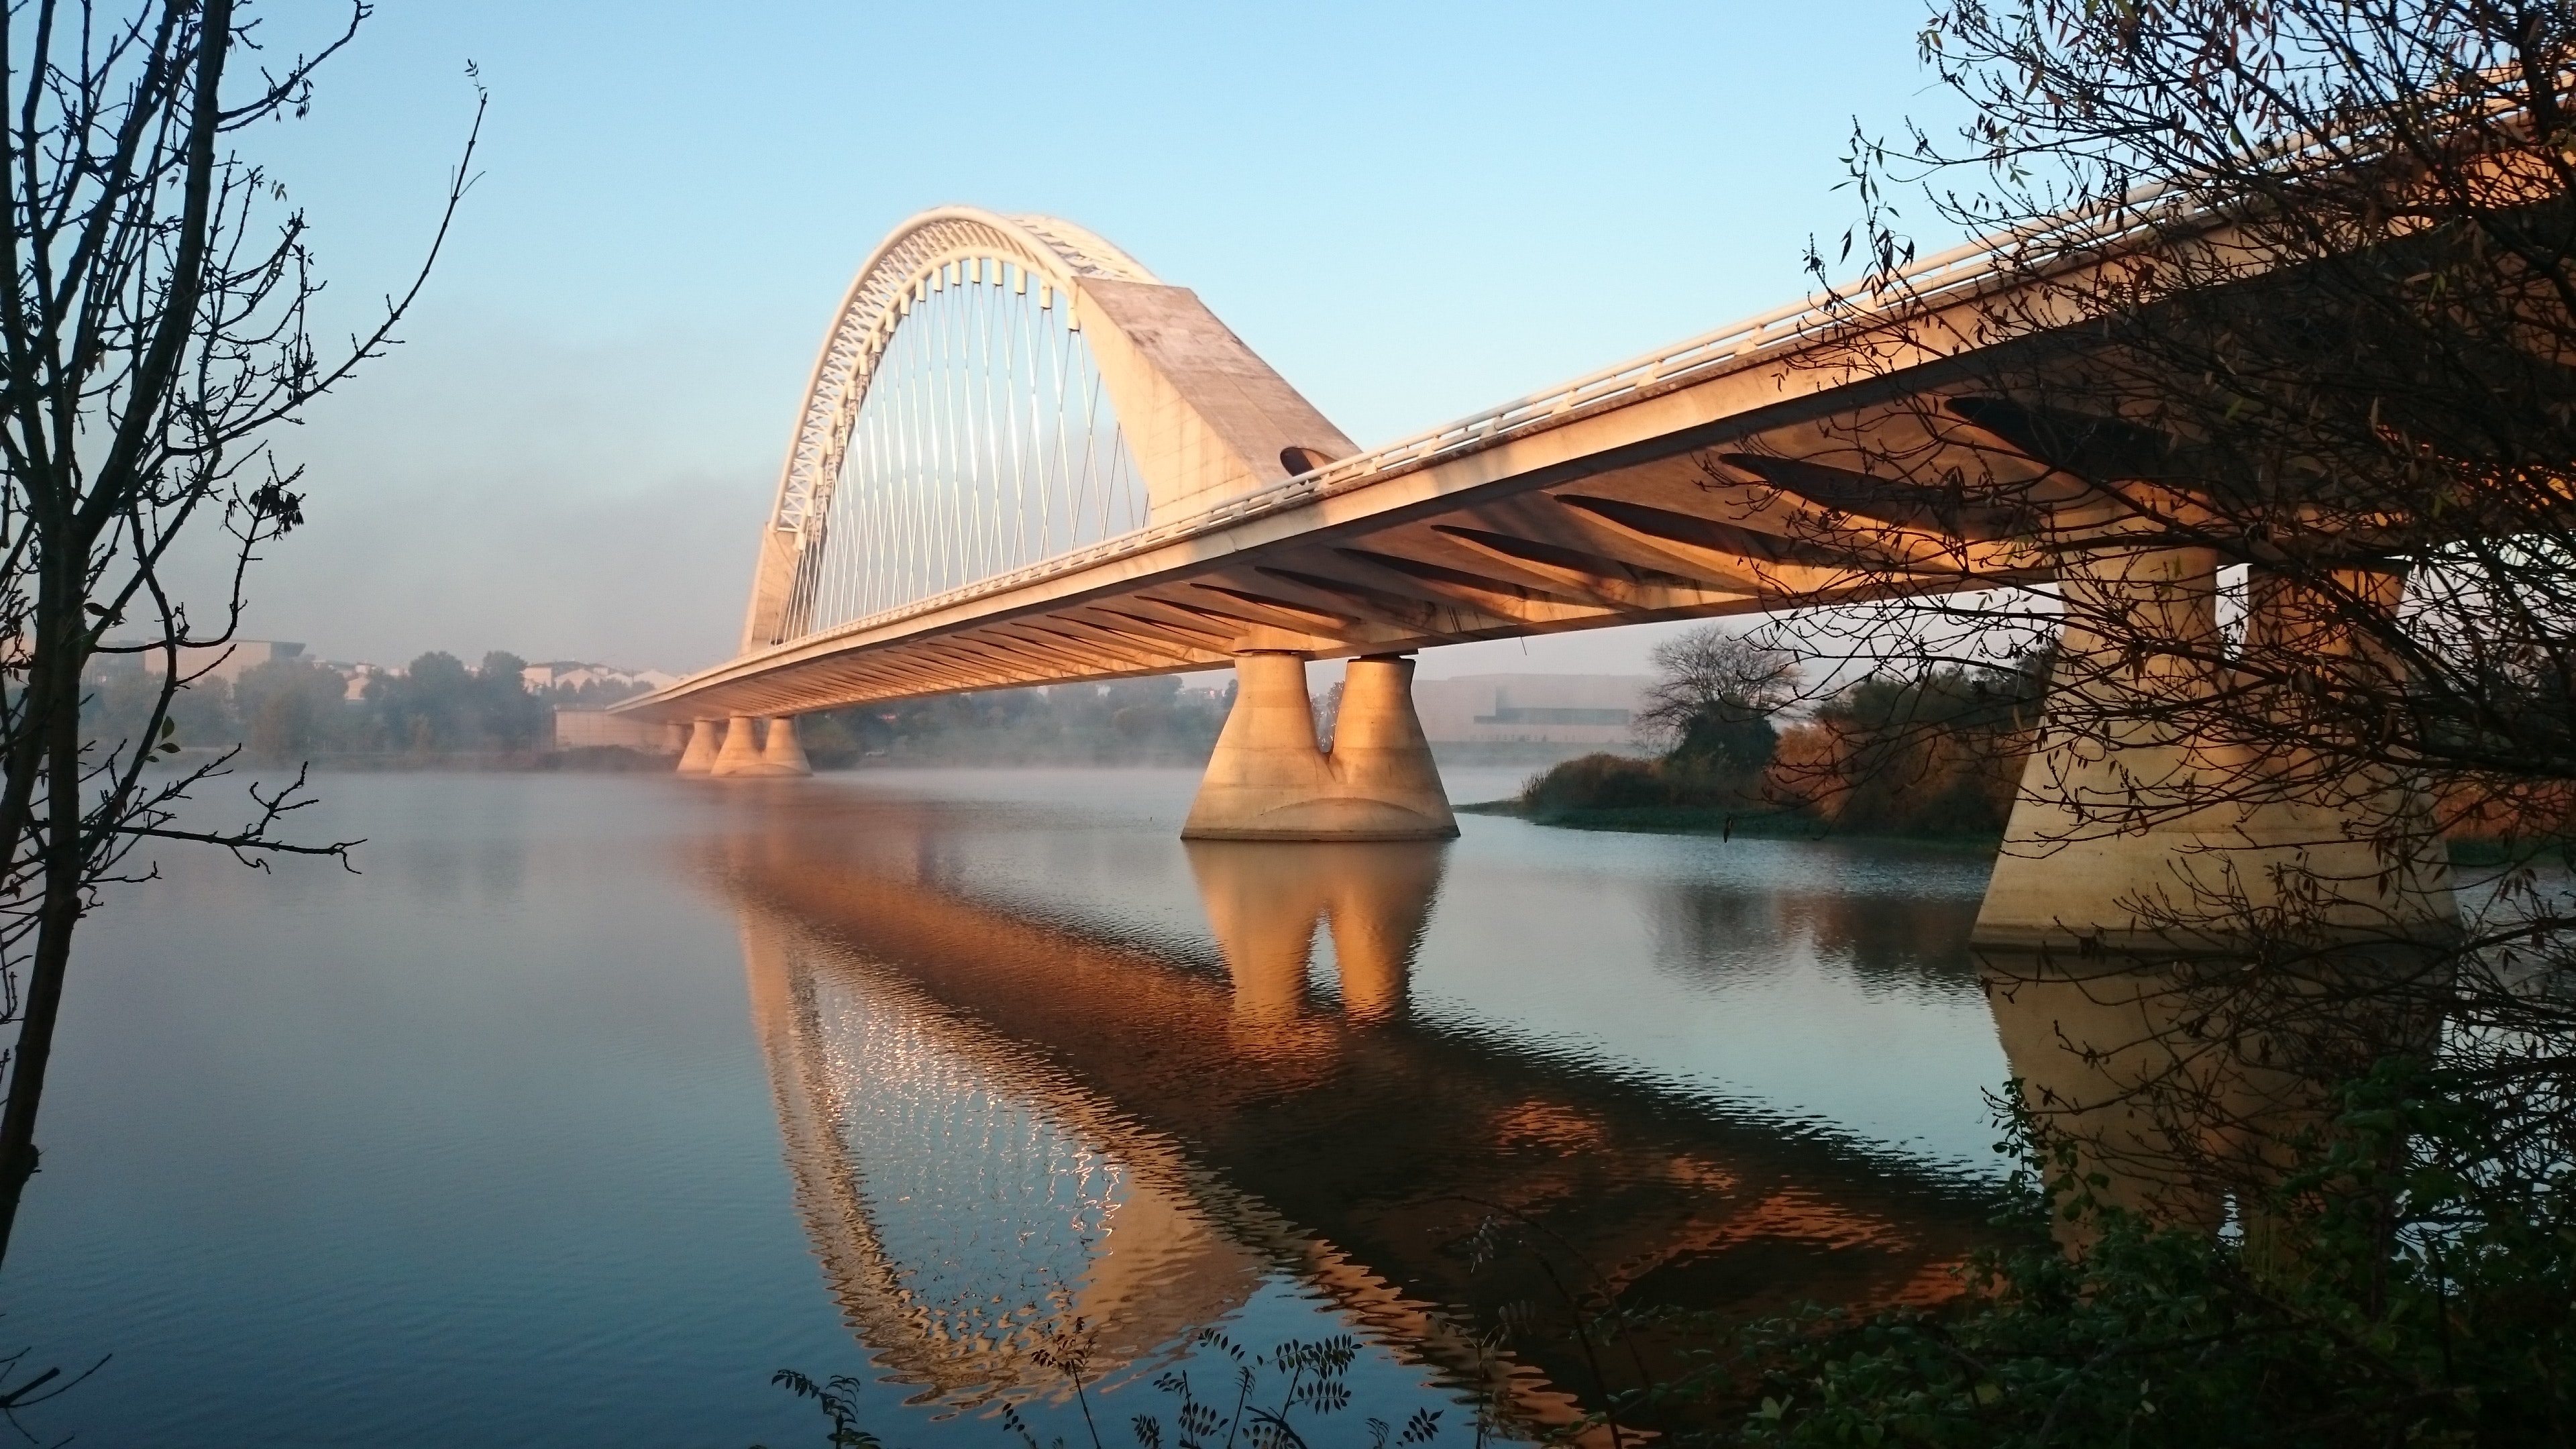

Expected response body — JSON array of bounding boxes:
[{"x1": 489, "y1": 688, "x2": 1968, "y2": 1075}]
[{"x1": 796, "y1": 676, "x2": 1234, "y2": 768}]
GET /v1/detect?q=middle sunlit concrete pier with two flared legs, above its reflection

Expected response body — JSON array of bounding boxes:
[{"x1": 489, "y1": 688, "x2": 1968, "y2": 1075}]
[{"x1": 1180, "y1": 652, "x2": 1458, "y2": 841}]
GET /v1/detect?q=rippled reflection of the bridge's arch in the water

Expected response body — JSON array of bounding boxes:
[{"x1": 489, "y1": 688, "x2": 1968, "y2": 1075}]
[{"x1": 742, "y1": 908, "x2": 1265, "y2": 1400}]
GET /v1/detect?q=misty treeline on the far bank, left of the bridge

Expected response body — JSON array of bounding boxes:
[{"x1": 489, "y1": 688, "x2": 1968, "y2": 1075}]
[{"x1": 83, "y1": 650, "x2": 590, "y2": 761}]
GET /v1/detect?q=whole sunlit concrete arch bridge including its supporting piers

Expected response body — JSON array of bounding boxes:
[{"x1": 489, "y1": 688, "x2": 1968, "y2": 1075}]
[{"x1": 619, "y1": 206, "x2": 2453, "y2": 947}]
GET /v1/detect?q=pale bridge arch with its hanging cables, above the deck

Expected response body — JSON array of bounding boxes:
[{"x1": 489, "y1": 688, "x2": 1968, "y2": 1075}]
[{"x1": 742, "y1": 206, "x2": 1352, "y2": 652}]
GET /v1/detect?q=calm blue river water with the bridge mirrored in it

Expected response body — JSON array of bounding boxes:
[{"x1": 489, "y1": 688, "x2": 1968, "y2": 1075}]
[{"x1": 0, "y1": 771, "x2": 2006, "y2": 1449}]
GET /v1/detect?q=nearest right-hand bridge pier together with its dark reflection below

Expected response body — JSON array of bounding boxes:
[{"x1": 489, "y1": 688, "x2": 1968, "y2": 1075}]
[{"x1": 1973, "y1": 547, "x2": 2457, "y2": 1250}]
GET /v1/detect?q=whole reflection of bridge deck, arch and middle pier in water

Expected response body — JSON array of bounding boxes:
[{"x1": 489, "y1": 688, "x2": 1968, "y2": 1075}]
[{"x1": 716, "y1": 802, "x2": 1986, "y2": 1428}]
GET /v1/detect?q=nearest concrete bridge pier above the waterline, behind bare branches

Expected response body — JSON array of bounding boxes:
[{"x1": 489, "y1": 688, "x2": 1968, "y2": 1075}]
[{"x1": 1973, "y1": 547, "x2": 2457, "y2": 951}]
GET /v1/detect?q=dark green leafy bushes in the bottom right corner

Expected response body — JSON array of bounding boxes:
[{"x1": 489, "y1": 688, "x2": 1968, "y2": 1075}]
[{"x1": 1736, "y1": 1060, "x2": 2576, "y2": 1449}]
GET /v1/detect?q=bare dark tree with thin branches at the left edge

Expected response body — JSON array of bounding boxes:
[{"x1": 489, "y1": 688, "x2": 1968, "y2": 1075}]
[{"x1": 0, "y1": 0, "x2": 482, "y2": 1253}]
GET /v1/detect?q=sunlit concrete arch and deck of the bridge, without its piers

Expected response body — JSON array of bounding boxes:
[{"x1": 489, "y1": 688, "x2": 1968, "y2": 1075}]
[{"x1": 616, "y1": 209, "x2": 2053, "y2": 719}]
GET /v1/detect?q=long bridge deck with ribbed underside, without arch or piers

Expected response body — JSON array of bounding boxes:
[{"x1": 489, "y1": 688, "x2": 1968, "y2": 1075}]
[{"x1": 631, "y1": 345, "x2": 2048, "y2": 722}]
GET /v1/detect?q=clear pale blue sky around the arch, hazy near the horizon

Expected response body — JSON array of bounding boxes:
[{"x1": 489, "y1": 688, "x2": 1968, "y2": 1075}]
[{"x1": 221, "y1": 0, "x2": 1942, "y2": 678}]
